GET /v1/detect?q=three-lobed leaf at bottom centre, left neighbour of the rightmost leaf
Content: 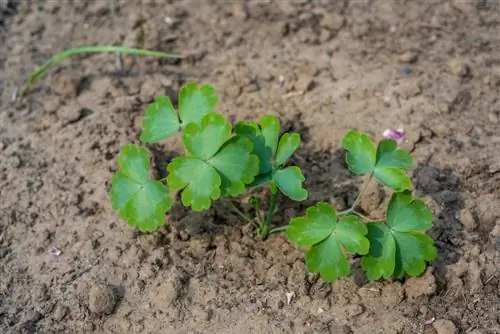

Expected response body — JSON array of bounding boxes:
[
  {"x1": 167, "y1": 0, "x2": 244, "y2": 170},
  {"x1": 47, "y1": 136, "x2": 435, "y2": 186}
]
[{"x1": 285, "y1": 203, "x2": 370, "y2": 282}]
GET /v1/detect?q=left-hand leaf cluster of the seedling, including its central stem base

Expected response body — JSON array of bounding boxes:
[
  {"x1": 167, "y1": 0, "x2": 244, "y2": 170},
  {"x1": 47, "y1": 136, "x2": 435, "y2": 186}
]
[{"x1": 111, "y1": 83, "x2": 307, "y2": 238}]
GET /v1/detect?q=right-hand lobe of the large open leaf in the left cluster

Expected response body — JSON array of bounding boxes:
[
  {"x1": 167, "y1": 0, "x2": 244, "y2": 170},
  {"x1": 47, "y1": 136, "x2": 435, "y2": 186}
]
[{"x1": 208, "y1": 137, "x2": 259, "y2": 196}]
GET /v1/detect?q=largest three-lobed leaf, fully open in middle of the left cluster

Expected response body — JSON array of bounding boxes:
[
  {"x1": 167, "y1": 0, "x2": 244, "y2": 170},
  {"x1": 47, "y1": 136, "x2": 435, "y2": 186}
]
[{"x1": 167, "y1": 112, "x2": 259, "y2": 211}]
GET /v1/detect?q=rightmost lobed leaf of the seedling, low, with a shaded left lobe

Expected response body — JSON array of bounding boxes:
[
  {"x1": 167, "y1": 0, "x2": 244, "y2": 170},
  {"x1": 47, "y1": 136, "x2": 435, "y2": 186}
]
[{"x1": 361, "y1": 191, "x2": 437, "y2": 280}]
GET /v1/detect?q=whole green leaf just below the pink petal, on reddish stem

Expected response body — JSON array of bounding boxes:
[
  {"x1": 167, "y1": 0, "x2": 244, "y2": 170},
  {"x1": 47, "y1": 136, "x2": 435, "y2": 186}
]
[{"x1": 342, "y1": 131, "x2": 414, "y2": 191}]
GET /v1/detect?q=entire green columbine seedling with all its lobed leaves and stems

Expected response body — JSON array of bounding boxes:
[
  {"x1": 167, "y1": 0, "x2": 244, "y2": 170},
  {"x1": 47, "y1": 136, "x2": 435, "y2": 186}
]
[{"x1": 110, "y1": 83, "x2": 437, "y2": 282}]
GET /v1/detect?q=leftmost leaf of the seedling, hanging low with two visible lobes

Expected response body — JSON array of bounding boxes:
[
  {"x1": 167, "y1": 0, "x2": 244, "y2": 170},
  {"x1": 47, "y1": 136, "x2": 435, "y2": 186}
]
[{"x1": 110, "y1": 144, "x2": 172, "y2": 232}]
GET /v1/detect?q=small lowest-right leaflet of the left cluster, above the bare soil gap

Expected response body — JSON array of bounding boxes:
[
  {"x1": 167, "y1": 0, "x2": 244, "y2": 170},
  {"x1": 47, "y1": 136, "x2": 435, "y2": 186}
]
[{"x1": 273, "y1": 166, "x2": 308, "y2": 201}]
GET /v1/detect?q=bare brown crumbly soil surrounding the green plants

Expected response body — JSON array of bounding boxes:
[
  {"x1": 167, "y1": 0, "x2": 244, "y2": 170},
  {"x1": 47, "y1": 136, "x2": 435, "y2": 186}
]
[{"x1": 0, "y1": 0, "x2": 500, "y2": 334}]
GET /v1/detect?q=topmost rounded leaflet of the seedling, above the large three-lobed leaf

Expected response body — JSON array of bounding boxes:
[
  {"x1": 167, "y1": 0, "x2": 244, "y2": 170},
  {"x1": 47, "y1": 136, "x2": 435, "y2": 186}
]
[{"x1": 179, "y1": 82, "x2": 219, "y2": 125}]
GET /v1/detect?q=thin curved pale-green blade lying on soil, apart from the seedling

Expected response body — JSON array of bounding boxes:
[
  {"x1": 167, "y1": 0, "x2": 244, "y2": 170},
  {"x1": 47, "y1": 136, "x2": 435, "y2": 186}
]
[{"x1": 21, "y1": 45, "x2": 182, "y2": 97}]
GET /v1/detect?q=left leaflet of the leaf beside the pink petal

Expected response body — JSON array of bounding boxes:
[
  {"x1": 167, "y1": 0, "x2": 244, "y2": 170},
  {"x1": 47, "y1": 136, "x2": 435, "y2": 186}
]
[{"x1": 342, "y1": 130, "x2": 376, "y2": 175}]
